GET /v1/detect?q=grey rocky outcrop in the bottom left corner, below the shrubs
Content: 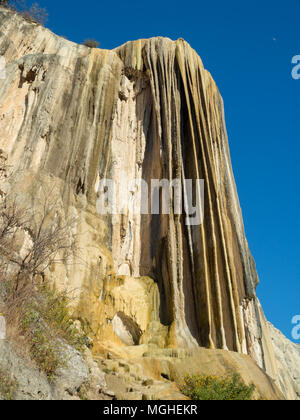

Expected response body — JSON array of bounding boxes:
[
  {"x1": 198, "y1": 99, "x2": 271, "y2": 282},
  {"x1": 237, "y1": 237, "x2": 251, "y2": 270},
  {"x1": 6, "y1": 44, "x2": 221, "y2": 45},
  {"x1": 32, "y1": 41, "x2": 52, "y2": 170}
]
[{"x1": 0, "y1": 340, "x2": 112, "y2": 401}]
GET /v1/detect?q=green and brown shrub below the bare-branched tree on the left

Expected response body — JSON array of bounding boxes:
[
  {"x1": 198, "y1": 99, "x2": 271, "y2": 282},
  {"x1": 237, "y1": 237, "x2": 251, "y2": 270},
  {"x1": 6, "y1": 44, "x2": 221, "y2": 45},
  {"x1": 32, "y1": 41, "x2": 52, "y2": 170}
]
[{"x1": 5, "y1": 281, "x2": 87, "y2": 380}]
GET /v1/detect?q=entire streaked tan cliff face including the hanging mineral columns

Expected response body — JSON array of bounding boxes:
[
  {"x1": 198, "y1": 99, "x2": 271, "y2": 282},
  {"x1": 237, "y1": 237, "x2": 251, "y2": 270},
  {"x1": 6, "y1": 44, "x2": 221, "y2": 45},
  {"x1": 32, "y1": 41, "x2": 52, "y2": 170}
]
[{"x1": 0, "y1": 8, "x2": 294, "y2": 397}]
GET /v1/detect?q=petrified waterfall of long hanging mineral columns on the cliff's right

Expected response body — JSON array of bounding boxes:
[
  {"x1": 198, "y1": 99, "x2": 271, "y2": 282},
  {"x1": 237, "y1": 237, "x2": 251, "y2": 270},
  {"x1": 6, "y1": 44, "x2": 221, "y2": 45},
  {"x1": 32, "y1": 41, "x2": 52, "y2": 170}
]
[{"x1": 112, "y1": 38, "x2": 257, "y2": 352}]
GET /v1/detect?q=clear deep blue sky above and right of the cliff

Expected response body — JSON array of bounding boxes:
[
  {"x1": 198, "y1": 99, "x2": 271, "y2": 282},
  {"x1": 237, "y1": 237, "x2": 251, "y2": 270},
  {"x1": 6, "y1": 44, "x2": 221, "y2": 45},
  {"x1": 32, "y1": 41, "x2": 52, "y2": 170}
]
[{"x1": 33, "y1": 0, "x2": 300, "y2": 338}]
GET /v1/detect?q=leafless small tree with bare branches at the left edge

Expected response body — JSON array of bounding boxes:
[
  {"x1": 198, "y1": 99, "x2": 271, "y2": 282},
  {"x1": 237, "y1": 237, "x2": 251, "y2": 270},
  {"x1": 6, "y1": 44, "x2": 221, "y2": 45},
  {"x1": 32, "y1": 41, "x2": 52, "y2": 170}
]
[{"x1": 0, "y1": 187, "x2": 76, "y2": 291}]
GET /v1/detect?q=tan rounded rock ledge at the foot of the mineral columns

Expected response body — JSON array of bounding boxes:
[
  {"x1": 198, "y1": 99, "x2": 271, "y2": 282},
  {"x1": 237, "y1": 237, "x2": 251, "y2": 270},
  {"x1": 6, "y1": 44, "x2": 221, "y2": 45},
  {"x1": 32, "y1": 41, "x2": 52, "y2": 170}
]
[{"x1": 93, "y1": 346, "x2": 284, "y2": 400}]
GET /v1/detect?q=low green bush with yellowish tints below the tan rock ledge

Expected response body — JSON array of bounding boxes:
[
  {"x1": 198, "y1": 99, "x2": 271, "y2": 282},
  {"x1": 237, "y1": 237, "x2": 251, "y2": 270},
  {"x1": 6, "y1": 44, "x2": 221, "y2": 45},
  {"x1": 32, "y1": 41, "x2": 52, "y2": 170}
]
[{"x1": 181, "y1": 374, "x2": 255, "y2": 401}]
